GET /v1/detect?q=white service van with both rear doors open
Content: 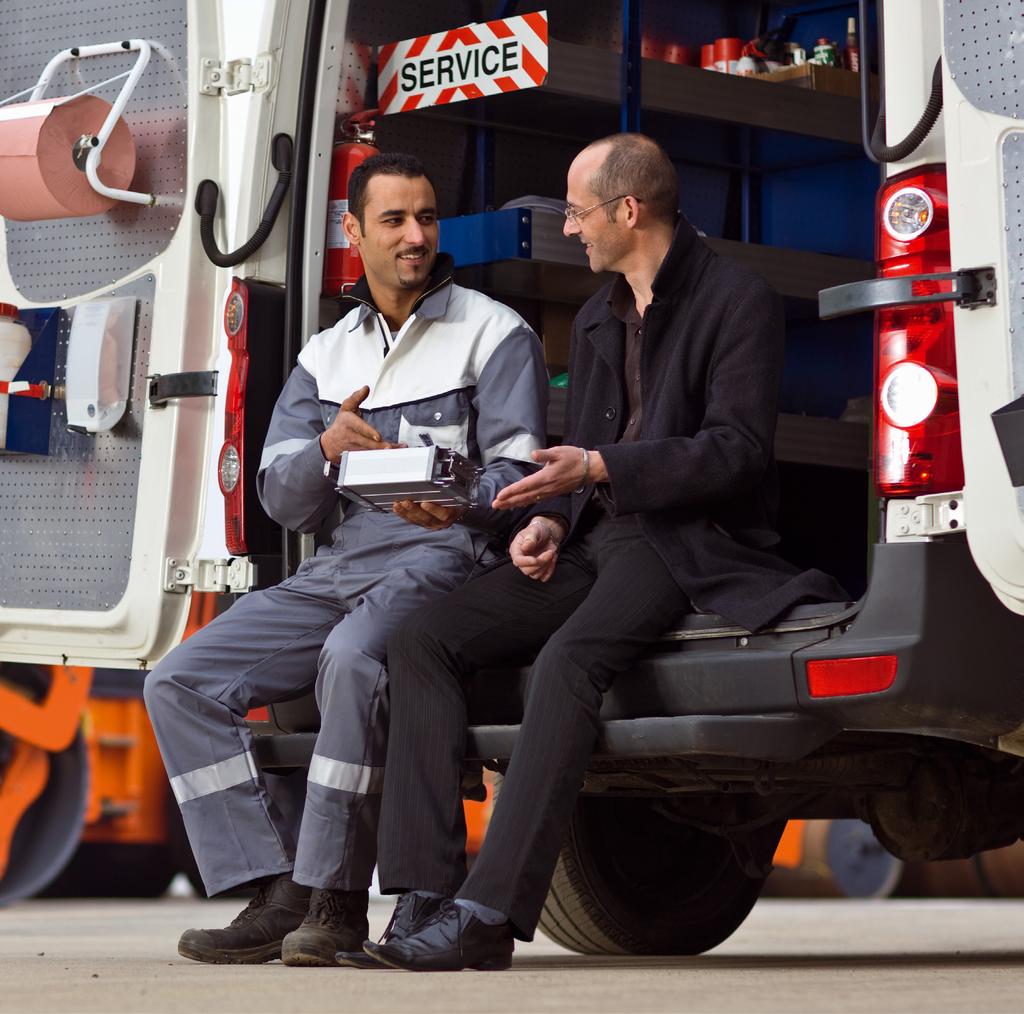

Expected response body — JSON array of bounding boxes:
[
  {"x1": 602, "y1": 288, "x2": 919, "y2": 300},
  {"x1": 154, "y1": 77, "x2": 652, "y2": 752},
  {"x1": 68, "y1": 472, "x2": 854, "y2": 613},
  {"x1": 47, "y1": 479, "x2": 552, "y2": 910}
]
[{"x1": 0, "y1": 0, "x2": 1024, "y2": 954}]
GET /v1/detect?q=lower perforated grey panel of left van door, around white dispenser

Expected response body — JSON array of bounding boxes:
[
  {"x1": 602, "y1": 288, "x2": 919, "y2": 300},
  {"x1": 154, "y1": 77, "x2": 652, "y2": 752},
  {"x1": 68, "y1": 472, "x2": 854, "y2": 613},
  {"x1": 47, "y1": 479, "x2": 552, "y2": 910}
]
[{"x1": 0, "y1": 274, "x2": 156, "y2": 610}]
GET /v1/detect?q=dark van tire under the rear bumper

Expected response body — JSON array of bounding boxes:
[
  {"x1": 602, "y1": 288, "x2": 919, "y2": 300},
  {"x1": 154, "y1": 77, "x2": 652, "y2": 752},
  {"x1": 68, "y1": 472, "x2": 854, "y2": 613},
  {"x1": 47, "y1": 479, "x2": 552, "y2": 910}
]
[{"x1": 540, "y1": 797, "x2": 764, "y2": 955}]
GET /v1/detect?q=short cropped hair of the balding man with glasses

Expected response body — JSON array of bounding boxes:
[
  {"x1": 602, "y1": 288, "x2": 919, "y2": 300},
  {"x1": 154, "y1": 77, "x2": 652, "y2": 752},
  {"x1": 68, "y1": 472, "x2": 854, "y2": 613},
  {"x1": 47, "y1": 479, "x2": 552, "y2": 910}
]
[{"x1": 589, "y1": 134, "x2": 679, "y2": 224}]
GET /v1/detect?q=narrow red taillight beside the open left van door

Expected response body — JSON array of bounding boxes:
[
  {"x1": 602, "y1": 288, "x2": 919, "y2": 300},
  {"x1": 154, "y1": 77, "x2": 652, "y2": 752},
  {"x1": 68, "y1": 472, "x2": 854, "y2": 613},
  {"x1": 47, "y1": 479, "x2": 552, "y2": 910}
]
[{"x1": 217, "y1": 279, "x2": 249, "y2": 556}]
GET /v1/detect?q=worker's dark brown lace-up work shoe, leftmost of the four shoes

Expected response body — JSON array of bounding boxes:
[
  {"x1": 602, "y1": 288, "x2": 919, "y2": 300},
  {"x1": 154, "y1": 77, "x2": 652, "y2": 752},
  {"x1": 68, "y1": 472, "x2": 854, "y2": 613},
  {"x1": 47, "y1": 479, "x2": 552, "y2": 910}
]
[{"x1": 178, "y1": 874, "x2": 310, "y2": 965}]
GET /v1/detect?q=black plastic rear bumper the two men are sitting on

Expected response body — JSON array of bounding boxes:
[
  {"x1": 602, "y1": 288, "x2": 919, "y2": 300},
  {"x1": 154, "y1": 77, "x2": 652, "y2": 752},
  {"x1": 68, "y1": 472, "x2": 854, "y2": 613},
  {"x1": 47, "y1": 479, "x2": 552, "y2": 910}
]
[{"x1": 251, "y1": 538, "x2": 1024, "y2": 767}]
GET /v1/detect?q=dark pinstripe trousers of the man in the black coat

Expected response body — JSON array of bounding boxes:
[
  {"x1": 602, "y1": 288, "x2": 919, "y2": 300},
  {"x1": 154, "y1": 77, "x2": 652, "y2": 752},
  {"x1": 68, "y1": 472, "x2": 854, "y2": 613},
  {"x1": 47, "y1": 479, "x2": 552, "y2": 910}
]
[{"x1": 378, "y1": 509, "x2": 690, "y2": 940}]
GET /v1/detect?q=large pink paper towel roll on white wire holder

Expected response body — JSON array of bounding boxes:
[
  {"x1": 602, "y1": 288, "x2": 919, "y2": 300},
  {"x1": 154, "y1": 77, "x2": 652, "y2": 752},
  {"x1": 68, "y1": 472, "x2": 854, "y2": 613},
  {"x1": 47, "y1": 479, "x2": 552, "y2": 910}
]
[{"x1": 0, "y1": 95, "x2": 135, "y2": 222}]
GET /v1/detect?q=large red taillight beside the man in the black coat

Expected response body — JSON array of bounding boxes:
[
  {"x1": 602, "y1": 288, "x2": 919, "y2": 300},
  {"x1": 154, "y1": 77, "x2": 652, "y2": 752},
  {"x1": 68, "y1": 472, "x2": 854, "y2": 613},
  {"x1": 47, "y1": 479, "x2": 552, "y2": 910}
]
[{"x1": 874, "y1": 168, "x2": 964, "y2": 497}]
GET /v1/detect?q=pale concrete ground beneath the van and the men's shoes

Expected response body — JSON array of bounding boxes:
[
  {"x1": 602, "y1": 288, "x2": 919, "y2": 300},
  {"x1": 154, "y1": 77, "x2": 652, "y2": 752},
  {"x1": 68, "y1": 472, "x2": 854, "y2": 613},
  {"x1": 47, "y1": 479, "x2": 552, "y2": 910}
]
[{"x1": 0, "y1": 898, "x2": 1024, "y2": 1014}]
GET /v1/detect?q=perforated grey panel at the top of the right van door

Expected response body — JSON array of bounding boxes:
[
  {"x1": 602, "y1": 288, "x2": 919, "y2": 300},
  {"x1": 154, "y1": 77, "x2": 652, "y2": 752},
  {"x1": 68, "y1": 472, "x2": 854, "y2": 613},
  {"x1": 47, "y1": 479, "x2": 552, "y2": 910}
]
[{"x1": 943, "y1": 0, "x2": 1024, "y2": 119}]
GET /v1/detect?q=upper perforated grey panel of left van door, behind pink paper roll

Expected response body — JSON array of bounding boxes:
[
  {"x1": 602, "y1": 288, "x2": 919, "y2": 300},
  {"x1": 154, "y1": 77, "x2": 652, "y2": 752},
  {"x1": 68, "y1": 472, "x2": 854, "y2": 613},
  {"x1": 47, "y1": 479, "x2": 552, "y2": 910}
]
[{"x1": 0, "y1": 0, "x2": 188, "y2": 303}]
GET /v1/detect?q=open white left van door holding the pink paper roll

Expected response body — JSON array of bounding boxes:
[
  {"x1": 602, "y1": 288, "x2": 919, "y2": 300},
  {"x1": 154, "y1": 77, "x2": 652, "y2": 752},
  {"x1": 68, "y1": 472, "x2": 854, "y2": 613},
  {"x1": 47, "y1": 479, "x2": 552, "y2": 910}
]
[{"x1": 0, "y1": 0, "x2": 309, "y2": 668}]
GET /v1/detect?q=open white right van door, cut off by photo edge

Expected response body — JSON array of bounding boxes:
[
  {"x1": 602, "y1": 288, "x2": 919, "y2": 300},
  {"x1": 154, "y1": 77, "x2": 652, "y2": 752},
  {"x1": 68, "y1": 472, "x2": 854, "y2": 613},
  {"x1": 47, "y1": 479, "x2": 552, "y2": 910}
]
[{"x1": 942, "y1": 0, "x2": 1024, "y2": 612}]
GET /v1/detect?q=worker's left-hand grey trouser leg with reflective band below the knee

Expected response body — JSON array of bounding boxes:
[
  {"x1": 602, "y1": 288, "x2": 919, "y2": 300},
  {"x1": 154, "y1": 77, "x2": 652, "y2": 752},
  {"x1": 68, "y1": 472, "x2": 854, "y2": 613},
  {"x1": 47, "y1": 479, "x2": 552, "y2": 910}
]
[{"x1": 145, "y1": 566, "x2": 347, "y2": 894}]
